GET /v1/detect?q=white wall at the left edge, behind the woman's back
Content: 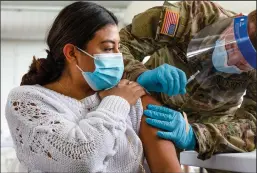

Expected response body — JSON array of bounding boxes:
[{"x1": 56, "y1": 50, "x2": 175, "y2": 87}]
[{"x1": 1, "y1": 40, "x2": 47, "y2": 145}]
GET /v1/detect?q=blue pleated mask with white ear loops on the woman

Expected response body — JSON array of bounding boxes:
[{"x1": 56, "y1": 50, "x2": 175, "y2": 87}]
[{"x1": 77, "y1": 47, "x2": 124, "y2": 91}]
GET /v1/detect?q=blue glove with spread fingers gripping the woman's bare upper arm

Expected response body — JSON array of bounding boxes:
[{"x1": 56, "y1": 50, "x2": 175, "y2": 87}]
[{"x1": 144, "y1": 105, "x2": 196, "y2": 150}]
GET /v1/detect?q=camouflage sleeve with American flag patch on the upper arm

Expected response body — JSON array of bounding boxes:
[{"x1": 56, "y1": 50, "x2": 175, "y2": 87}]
[{"x1": 120, "y1": 1, "x2": 235, "y2": 80}]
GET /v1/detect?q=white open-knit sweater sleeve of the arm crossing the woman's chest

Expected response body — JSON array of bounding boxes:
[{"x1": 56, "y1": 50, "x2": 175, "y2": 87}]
[{"x1": 6, "y1": 87, "x2": 130, "y2": 172}]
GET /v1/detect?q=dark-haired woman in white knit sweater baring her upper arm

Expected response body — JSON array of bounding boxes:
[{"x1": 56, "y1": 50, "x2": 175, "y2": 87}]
[{"x1": 6, "y1": 2, "x2": 181, "y2": 172}]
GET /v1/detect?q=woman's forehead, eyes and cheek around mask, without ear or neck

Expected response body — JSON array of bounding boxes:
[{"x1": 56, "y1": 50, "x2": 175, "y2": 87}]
[{"x1": 77, "y1": 25, "x2": 120, "y2": 72}]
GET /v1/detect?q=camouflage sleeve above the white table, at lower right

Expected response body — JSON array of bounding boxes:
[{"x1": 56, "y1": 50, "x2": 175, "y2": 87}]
[{"x1": 192, "y1": 70, "x2": 257, "y2": 160}]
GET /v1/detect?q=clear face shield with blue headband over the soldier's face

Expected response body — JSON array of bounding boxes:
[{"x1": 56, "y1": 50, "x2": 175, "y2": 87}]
[{"x1": 187, "y1": 16, "x2": 256, "y2": 74}]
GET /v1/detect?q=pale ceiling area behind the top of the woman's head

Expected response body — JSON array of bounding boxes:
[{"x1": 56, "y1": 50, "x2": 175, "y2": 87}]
[{"x1": 1, "y1": 1, "x2": 131, "y2": 40}]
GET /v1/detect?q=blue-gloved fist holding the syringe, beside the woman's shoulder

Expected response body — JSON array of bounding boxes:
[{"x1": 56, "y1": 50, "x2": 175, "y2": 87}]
[{"x1": 137, "y1": 64, "x2": 187, "y2": 96}]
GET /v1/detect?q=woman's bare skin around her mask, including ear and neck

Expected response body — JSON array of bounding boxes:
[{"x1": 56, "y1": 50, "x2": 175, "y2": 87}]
[{"x1": 63, "y1": 25, "x2": 120, "y2": 87}]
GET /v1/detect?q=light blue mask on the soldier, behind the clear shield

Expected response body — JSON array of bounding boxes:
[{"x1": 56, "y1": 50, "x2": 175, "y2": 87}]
[{"x1": 212, "y1": 40, "x2": 242, "y2": 74}]
